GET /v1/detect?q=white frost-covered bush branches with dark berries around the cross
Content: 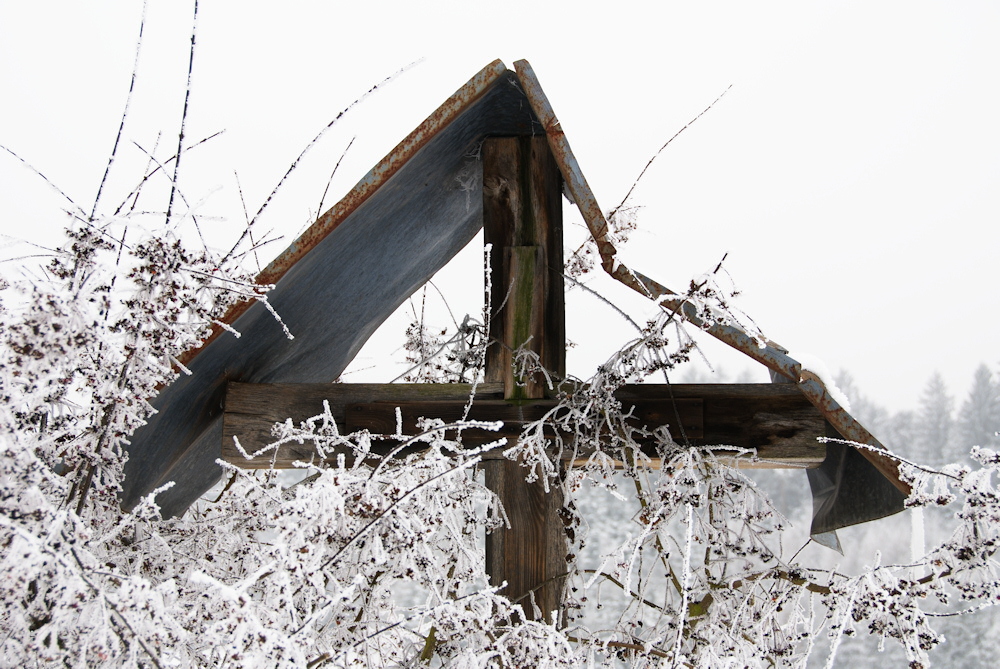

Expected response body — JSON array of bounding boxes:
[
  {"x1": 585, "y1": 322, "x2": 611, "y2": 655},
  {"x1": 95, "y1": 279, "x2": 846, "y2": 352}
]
[{"x1": 0, "y1": 15, "x2": 1000, "y2": 669}]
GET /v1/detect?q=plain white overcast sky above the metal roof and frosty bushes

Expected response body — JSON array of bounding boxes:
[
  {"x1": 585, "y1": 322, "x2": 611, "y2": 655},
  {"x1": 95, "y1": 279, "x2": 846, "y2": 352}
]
[{"x1": 0, "y1": 0, "x2": 1000, "y2": 418}]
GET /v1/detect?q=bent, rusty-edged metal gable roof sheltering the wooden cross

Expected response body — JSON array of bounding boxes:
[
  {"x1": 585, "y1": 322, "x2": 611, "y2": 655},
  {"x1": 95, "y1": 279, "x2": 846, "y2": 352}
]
[{"x1": 122, "y1": 60, "x2": 908, "y2": 529}]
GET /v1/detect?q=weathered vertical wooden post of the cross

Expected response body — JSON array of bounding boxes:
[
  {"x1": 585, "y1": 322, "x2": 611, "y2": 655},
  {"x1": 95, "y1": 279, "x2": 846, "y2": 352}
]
[{"x1": 482, "y1": 137, "x2": 567, "y2": 622}]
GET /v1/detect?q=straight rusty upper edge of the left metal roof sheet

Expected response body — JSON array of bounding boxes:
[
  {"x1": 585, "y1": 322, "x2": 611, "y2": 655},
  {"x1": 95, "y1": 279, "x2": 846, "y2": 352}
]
[{"x1": 178, "y1": 60, "x2": 507, "y2": 365}]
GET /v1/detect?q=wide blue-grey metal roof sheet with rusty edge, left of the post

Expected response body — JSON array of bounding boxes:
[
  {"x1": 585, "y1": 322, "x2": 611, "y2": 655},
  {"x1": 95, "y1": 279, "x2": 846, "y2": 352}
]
[{"x1": 121, "y1": 61, "x2": 541, "y2": 515}]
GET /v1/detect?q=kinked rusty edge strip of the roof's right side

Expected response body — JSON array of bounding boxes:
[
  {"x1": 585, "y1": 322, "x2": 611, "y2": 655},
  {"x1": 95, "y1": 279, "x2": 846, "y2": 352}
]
[{"x1": 514, "y1": 60, "x2": 910, "y2": 494}]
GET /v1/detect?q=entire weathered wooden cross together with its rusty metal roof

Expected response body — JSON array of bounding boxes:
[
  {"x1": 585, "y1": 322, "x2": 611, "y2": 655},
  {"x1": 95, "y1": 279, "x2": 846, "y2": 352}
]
[{"x1": 111, "y1": 60, "x2": 909, "y2": 617}]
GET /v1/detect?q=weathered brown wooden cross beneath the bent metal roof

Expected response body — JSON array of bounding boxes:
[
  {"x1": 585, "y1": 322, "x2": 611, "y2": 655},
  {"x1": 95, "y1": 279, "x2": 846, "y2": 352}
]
[{"x1": 222, "y1": 136, "x2": 826, "y2": 622}]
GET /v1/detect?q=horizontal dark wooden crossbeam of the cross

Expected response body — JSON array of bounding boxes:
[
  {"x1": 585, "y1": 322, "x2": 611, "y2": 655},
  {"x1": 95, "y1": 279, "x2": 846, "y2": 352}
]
[{"x1": 222, "y1": 383, "x2": 826, "y2": 469}]
